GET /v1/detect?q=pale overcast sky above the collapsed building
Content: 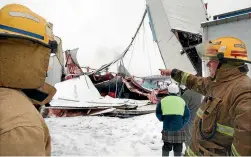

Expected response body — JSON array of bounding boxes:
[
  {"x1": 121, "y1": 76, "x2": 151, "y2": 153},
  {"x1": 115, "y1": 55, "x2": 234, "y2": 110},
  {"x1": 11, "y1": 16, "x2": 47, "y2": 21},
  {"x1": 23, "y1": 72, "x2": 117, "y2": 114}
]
[{"x1": 0, "y1": 0, "x2": 251, "y2": 75}]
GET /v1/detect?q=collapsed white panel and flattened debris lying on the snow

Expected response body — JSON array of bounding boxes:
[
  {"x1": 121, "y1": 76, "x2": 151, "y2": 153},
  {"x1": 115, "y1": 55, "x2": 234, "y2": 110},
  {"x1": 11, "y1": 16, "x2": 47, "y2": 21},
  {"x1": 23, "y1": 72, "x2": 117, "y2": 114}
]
[{"x1": 46, "y1": 75, "x2": 155, "y2": 117}]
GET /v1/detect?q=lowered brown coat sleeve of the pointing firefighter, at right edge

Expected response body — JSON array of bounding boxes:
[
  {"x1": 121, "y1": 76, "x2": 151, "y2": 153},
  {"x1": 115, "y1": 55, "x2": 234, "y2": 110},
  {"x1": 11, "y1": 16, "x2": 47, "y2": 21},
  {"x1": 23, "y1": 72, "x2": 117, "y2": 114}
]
[{"x1": 230, "y1": 86, "x2": 251, "y2": 156}]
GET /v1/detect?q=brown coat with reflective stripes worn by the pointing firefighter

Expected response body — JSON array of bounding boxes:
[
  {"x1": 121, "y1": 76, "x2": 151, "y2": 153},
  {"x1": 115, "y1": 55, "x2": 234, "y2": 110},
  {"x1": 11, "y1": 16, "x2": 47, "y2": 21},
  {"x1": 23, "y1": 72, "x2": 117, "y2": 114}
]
[{"x1": 172, "y1": 66, "x2": 251, "y2": 156}]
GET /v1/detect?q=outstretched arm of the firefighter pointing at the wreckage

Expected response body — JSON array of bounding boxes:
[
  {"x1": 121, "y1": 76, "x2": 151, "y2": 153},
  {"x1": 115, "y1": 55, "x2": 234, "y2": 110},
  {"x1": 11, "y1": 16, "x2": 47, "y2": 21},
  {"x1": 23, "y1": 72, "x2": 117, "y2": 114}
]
[{"x1": 160, "y1": 69, "x2": 211, "y2": 95}]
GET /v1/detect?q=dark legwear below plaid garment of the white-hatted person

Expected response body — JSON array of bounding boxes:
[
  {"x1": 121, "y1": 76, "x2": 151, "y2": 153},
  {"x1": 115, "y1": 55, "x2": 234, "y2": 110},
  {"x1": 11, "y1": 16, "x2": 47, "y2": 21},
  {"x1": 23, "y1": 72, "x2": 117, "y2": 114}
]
[{"x1": 162, "y1": 142, "x2": 183, "y2": 156}]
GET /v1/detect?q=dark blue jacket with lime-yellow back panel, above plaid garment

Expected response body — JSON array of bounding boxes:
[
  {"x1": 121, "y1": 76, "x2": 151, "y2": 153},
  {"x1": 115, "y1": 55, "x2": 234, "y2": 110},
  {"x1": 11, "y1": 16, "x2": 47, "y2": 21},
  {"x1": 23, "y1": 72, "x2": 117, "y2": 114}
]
[{"x1": 156, "y1": 96, "x2": 190, "y2": 131}]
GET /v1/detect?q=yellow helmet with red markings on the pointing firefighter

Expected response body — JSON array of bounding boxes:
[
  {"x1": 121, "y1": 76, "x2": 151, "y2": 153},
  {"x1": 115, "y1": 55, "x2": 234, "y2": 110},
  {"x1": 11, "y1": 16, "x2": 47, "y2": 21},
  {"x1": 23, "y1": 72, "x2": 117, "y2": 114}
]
[{"x1": 201, "y1": 37, "x2": 251, "y2": 63}]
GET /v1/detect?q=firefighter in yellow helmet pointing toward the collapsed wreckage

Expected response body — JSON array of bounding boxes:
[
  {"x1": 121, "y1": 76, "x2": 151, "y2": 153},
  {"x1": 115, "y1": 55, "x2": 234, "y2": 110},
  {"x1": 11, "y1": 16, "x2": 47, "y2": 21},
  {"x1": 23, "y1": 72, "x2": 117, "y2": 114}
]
[{"x1": 160, "y1": 37, "x2": 251, "y2": 156}]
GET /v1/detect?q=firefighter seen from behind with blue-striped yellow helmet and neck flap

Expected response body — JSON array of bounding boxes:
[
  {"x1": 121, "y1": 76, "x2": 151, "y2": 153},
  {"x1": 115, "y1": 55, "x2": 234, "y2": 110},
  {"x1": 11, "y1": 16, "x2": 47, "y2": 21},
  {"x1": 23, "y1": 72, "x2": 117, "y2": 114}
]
[{"x1": 0, "y1": 4, "x2": 57, "y2": 156}]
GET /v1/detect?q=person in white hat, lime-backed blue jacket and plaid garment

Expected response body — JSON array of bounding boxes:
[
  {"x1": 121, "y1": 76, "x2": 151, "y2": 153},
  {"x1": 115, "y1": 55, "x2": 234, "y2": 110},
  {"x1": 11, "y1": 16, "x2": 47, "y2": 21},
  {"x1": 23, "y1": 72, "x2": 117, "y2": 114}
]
[{"x1": 156, "y1": 84, "x2": 190, "y2": 156}]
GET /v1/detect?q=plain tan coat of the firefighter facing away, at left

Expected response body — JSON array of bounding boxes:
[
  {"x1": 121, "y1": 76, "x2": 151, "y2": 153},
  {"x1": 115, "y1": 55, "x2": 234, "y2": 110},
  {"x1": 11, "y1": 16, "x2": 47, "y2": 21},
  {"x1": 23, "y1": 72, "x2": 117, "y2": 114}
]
[{"x1": 0, "y1": 87, "x2": 51, "y2": 156}]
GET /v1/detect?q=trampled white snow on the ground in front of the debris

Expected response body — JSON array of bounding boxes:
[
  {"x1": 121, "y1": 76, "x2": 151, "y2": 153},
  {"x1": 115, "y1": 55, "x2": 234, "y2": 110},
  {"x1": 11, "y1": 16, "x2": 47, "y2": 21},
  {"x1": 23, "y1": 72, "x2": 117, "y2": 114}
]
[{"x1": 45, "y1": 113, "x2": 184, "y2": 156}]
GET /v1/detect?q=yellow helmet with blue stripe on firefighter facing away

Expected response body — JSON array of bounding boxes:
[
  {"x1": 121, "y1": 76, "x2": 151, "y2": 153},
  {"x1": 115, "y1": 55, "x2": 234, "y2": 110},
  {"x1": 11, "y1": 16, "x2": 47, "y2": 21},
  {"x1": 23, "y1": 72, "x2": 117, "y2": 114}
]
[{"x1": 0, "y1": 4, "x2": 56, "y2": 49}]
